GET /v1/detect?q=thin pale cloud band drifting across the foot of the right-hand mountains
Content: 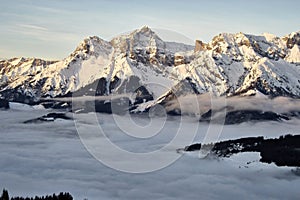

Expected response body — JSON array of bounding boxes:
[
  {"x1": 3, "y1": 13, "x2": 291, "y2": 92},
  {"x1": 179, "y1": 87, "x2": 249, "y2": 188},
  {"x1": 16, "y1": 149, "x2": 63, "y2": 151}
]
[{"x1": 166, "y1": 94, "x2": 300, "y2": 115}]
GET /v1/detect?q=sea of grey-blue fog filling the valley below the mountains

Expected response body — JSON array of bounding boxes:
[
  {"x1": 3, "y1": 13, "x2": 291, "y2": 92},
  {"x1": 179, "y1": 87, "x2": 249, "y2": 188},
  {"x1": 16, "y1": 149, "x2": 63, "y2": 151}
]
[{"x1": 0, "y1": 104, "x2": 300, "y2": 199}]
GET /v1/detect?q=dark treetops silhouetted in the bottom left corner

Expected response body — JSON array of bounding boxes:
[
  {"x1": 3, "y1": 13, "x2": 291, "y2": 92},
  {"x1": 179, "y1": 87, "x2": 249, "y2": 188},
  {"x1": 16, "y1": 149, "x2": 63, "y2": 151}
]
[{"x1": 0, "y1": 189, "x2": 73, "y2": 200}]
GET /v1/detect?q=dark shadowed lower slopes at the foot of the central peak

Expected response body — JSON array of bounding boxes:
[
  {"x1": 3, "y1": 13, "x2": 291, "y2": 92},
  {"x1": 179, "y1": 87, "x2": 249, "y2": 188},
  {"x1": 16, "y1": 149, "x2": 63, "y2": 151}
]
[{"x1": 39, "y1": 76, "x2": 154, "y2": 114}]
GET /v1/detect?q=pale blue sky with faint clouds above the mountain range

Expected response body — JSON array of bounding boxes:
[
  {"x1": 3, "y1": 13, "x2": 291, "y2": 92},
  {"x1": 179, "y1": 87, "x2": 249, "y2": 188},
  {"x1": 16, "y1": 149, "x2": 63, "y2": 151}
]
[{"x1": 0, "y1": 0, "x2": 300, "y2": 60}]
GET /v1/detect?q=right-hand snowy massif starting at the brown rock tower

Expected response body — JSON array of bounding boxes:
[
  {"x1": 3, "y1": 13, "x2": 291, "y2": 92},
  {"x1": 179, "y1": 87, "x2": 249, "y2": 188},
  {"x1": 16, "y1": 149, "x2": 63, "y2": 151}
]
[{"x1": 191, "y1": 32, "x2": 300, "y2": 97}]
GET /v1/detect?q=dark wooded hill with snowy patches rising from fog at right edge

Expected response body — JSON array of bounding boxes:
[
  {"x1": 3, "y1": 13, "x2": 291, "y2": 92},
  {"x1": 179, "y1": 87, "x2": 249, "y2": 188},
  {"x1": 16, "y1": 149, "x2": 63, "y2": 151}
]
[{"x1": 184, "y1": 135, "x2": 300, "y2": 167}]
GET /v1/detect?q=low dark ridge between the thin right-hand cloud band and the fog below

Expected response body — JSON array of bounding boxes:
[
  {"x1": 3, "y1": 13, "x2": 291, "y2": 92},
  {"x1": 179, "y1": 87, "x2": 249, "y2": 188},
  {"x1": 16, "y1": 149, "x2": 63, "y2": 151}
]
[{"x1": 200, "y1": 110, "x2": 290, "y2": 125}]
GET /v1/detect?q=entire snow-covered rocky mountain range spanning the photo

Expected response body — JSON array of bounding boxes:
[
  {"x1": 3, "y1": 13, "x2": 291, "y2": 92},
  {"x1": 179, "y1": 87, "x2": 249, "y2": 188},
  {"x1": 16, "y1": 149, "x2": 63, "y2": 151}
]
[{"x1": 0, "y1": 26, "x2": 300, "y2": 108}]
